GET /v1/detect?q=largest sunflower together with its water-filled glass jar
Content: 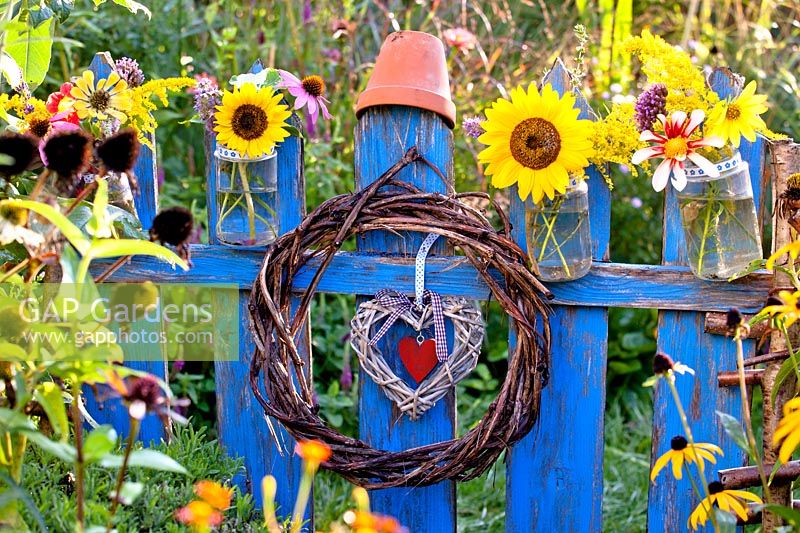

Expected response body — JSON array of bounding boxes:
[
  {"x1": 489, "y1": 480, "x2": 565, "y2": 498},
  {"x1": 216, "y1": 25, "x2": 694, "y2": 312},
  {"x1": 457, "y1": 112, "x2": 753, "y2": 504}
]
[{"x1": 476, "y1": 84, "x2": 592, "y2": 281}]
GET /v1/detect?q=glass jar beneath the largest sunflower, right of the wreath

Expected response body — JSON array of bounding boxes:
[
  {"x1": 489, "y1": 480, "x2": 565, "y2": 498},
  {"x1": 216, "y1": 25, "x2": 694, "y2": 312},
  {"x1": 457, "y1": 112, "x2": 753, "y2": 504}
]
[{"x1": 525, "y1": 180, "x2": 592, "y2": 281}]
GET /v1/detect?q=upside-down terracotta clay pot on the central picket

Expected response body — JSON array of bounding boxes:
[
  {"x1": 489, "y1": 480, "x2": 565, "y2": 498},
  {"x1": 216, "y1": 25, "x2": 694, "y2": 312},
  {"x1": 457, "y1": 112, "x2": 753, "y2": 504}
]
[{"x1": 356, "y1": 31, "x2": 456, "y2": 128}]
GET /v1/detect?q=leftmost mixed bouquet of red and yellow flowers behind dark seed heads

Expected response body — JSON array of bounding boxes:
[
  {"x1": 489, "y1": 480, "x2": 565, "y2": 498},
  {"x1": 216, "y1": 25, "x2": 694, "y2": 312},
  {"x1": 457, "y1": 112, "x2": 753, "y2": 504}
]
[{"x1": 0, "y1": 58, "x2": 194, "y2": 217}]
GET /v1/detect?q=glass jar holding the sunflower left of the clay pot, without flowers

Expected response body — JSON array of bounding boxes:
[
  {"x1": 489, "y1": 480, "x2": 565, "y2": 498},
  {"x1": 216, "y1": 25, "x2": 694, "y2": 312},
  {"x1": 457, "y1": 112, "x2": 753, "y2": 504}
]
[{"x1": 214, "y1": 145, "x2": 279, "y2": 247}]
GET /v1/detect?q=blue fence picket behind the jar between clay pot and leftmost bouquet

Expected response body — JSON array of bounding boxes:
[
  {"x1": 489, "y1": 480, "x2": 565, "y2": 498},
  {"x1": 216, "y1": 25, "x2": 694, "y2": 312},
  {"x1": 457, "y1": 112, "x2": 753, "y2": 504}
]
[{"x1": 209, "y1": 61, "x2": 311, "y2": 516}]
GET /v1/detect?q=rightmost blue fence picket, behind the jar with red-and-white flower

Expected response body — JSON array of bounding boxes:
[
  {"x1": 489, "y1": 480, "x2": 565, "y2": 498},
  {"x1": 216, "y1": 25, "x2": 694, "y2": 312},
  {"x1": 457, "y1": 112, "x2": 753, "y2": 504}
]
[{"x1": 648, "y1": 70, "x2": 766, "y2": 531}]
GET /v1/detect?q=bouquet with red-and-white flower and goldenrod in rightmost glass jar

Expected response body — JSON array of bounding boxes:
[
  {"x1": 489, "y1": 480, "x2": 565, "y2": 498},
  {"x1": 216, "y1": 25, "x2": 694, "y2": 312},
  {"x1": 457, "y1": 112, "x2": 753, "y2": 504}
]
[{"x1": 590, "y1": 30, "x2": 777, "y2": 280}]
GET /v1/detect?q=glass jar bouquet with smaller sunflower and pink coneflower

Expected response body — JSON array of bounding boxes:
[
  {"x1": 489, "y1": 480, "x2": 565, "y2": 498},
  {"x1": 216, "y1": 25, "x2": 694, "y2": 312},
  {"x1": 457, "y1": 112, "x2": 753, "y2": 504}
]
[{"x1": 200, "y1": 68, "x2": 331, "y2": 246}]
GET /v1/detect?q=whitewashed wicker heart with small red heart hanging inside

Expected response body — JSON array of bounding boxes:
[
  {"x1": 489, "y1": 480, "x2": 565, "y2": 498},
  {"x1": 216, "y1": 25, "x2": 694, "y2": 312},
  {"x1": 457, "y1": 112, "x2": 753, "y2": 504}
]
[{"x1": 350, "y1": 296, "x2": 483, "y2": 420}]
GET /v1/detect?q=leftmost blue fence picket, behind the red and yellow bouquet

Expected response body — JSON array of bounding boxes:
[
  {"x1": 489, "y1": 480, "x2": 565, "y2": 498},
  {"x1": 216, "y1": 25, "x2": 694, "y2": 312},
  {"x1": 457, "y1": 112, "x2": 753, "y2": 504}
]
[{"x1": 85, "y1": 52, "x2": 166, "y2": 443}]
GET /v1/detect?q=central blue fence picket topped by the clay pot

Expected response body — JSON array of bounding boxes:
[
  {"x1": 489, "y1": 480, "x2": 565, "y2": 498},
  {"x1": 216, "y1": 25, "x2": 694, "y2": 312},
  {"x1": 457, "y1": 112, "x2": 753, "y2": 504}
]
[{"x1": 352, "y1": 107, "x2": 456, "y2": 533}]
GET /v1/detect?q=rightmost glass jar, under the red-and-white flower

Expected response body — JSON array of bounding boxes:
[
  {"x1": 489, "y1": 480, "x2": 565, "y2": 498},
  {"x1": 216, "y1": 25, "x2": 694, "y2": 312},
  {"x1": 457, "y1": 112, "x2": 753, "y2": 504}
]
[{"x1": 678, "y1": 152, "x2": 762, "y2": 281}]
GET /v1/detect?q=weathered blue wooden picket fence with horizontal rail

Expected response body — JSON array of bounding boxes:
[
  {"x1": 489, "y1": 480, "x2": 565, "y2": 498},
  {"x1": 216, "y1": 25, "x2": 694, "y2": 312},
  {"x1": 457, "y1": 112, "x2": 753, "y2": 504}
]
[{"x1": 86, "y1": 46, "x2": 770, "y2": 533}]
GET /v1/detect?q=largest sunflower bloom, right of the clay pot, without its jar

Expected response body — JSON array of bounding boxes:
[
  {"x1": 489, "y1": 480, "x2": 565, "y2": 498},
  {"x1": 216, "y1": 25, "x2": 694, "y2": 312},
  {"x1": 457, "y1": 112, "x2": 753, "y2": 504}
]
[{"x1": 478, "y1": 83, "x2": 592, "y2": 203}]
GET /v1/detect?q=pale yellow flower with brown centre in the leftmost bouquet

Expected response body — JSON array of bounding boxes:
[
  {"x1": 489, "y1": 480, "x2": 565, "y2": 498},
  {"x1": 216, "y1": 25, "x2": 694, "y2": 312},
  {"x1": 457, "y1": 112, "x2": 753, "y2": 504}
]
[{"x1": 69, "y1": 70, "x2": 131, "y2": 122}]
